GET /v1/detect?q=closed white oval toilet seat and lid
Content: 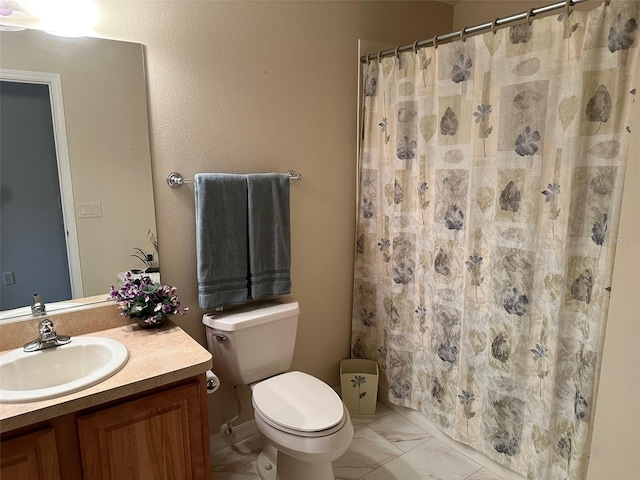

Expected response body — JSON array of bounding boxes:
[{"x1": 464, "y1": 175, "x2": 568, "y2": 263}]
[{"x1": 252, "y1": 372, "x2": 345, "y2": 437}]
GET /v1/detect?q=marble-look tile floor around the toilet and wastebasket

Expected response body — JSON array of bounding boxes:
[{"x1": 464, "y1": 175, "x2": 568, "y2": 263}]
[{"x1": 212, "y1": 403, "x2": 503, "y2": 480}]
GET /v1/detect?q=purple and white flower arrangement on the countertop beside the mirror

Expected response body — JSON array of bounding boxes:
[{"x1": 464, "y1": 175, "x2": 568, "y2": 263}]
[{"x1": 108, "y1": 272, "x2": 189, "y2": 326}]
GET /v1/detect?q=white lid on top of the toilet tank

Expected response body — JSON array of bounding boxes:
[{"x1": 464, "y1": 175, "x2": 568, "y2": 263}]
[{"x1": 202, "y1": 301, "x2": 300, "y2": 332}]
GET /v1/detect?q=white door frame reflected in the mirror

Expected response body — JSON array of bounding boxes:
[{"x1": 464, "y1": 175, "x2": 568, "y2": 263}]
[{"x1": 0, "y1": 68, "x2": 84, "y2": 298}]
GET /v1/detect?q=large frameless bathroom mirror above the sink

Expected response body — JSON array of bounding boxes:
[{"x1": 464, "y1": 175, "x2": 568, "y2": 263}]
[{"x1": 0, "y1": 29, "x2": 158, "y2": 320}]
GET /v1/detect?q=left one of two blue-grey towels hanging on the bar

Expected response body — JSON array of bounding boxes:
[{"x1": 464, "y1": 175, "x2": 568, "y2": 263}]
[{"x1": 195, "y1": 173, "x2": 249, "y2": 310}]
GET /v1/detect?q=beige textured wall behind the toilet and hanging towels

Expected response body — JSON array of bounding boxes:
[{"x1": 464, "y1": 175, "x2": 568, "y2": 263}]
[{"x1": 89, "y1": 1, "x2": 453, "y2": 433}]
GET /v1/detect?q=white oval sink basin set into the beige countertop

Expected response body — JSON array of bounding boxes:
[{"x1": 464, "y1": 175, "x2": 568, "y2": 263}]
[{"x1": 0, "y1": 337, "x2": 129, "y2": 403}]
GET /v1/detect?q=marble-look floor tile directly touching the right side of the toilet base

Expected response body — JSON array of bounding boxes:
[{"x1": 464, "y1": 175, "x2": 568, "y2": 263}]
[{"x1": 333, "y1": 425, "x2": 403, "y2": 480}]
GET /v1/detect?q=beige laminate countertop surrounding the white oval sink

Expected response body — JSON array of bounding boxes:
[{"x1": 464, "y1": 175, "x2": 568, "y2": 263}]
[{"x1": 0, "y1": 305, "x2": 212, "y2": 433}]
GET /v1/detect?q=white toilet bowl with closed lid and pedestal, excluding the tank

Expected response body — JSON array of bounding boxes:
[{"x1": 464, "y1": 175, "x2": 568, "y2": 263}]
[{"x1": 252, "y1": 372, "x2": 353, "y2": 480}]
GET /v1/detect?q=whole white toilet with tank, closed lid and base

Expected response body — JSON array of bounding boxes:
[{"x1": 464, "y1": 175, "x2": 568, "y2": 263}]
[{"x1": 202, "y1": 301, "x2": 353, "y2": 480}]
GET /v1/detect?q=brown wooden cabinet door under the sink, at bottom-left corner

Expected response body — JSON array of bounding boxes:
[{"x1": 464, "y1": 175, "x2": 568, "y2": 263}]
[{"x1": 0, "y1": 428, "x2": 60, "y2": 480}]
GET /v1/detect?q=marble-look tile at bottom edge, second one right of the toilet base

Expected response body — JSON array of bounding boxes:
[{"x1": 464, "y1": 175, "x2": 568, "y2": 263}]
[{"x1": 364, "y1": 439, "x2": 480, "y2": 480}]
